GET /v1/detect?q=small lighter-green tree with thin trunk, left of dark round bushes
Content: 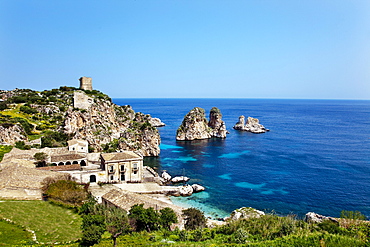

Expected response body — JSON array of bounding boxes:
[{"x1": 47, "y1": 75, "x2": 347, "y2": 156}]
[{"x1": 105, "y1": 207, "x2": 130, "y2": 246}]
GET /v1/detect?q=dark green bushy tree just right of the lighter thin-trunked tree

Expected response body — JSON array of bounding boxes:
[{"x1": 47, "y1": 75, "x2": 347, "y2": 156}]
[{"x1": 129, "y1": 204, "x2": 159, "y2": 232}]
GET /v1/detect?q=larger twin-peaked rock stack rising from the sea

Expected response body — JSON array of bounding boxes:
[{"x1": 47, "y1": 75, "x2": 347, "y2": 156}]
[{"x1": 176, "y1": 107, "x2": 227, "y2": 141}]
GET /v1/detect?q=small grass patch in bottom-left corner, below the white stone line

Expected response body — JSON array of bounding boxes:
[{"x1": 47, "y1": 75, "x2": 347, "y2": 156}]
[{"x1": 0, "y1": 220, "x2": 32, "y2": 246}]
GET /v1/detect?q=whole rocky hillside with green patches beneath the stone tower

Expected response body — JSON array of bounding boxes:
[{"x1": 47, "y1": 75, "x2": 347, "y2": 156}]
[{"x1": 0, "y1": 86, "x2": 160, "y2": 156}]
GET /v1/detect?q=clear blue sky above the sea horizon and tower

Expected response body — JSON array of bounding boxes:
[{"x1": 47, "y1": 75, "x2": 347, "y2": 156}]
[{"x1": 0, "y1": 0, "x2": 370, "y2": 99}]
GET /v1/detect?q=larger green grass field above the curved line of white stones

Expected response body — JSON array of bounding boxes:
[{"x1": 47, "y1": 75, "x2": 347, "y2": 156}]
[{"x1": 0, "y1": 201, "x2": 82, "y2": 243}]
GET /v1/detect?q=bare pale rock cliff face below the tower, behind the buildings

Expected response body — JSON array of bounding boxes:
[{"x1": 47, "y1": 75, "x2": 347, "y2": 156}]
[{"x1": 63, "y1": 92, "x2": 160, "y2": 156}]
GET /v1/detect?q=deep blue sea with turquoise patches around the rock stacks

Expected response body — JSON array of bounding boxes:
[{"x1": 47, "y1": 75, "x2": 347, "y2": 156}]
[{"x1": 113, "y1": 99, "x2": 370, "y2": 217}]
